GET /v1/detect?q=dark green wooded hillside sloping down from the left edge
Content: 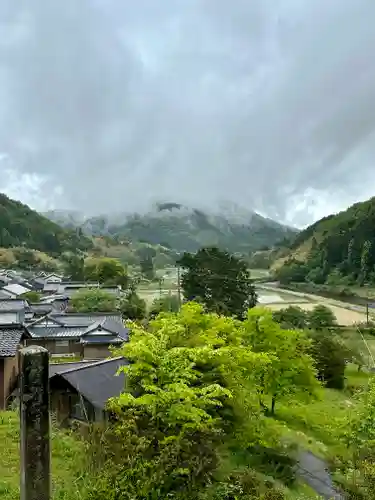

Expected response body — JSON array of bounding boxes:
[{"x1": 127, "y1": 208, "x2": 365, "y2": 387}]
[{"x1": 0, "y1": 194, "x2": 92, "y2": 255}]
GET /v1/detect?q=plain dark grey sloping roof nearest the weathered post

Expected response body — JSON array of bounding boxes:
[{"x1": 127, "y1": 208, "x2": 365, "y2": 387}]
[{"x1": 50, "y1": 358, "x2": 128, "y2": 410}]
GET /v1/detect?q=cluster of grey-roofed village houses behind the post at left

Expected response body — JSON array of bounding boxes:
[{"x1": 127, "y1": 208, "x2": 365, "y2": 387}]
[{"x1": 0, "y1": 270, "x2": 129, "y2": 421}]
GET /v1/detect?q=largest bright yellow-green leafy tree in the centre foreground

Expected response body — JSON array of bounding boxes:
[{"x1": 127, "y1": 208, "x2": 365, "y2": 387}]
[{"x1": 89, "y1": 303, "x2": 294, "y2": 500}]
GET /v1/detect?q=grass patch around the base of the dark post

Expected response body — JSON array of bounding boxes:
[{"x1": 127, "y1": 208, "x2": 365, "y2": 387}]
[{"x1": 0, "y1": 411, "x2": 89, "y2": 500}]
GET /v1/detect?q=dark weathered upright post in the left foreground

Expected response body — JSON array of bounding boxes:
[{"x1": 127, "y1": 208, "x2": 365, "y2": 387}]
[{"x1": 19, "y1": 346, "x2": 51, "y2": 500}]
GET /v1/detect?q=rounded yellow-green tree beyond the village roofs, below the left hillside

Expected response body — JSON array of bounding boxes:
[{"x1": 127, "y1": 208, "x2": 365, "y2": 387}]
[{"x1": 84, "y1": 257, "x2": 128, "y2": 288}]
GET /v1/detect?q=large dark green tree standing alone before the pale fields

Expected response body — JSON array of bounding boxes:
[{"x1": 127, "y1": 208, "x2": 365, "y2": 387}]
[{"x1": 179, "y1": 247, "x2": 257, "y2": 318}]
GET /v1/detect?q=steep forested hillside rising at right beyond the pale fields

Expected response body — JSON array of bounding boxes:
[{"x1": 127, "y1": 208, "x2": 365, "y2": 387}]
[{"x1": 275, "y1": 198, "x2": 375, "y2": 285}]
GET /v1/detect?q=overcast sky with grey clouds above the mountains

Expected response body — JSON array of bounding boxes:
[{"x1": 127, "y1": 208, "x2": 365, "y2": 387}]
[{"x1": 0, "y1": 0, "x2": 375, "y2": 225}]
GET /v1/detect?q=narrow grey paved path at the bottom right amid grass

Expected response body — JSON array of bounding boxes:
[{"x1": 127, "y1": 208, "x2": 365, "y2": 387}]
[{"x1": 297, "y1": 450, "x2": 344, "y2": 500}]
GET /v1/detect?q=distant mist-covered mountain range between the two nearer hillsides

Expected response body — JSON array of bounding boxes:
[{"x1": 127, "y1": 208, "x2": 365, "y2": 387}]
[{"x1": 44, "y1": 202, "x2": 297, "y2": 254}]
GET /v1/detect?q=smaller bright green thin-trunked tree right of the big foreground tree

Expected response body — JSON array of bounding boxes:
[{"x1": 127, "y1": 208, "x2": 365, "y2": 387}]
[{"x1": 243, "y1": 308, "x2": 319, "y2": 413}]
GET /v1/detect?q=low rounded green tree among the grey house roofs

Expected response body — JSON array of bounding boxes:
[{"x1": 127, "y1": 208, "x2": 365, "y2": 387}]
[{"x1": 71, "y1": 288, "x2": 117, "y2": 312}]
